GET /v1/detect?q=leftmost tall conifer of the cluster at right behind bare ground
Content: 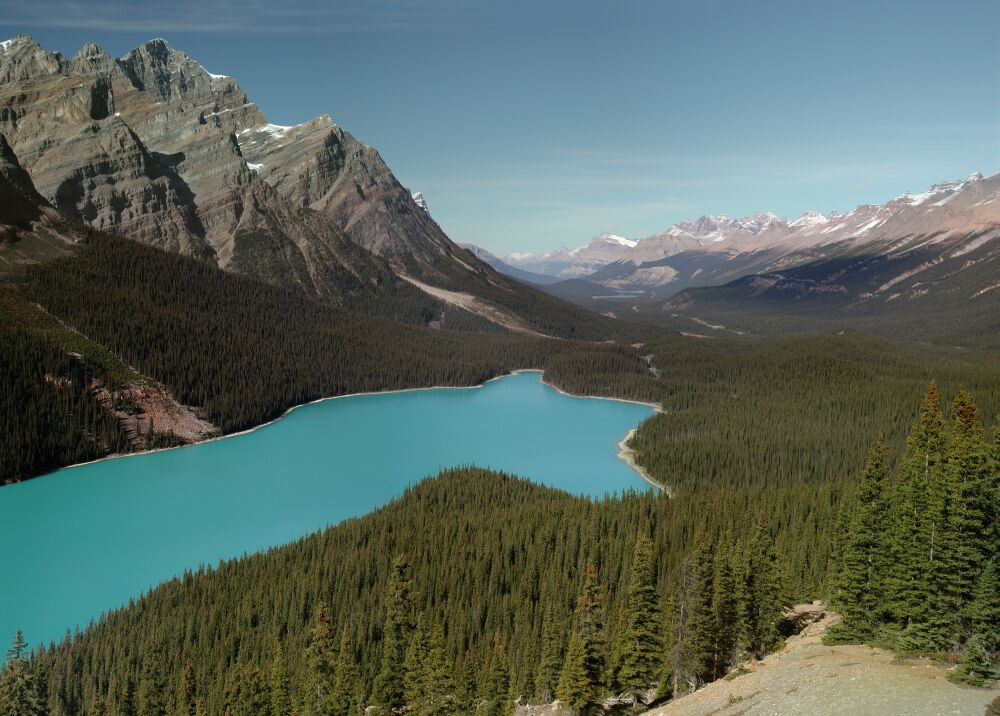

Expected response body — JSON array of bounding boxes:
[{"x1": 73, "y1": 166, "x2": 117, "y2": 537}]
[{"x1": 830, "y1": 441, "x2": 888, "y2": 642}]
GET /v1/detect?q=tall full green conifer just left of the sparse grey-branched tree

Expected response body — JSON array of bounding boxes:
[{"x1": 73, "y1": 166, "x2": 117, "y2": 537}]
[{"x1": 618, "y1": 532, "x2": 663, "y2": 702}]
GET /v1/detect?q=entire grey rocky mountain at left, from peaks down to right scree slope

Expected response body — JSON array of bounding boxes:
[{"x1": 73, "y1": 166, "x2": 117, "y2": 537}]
[{"x1": 0, "y1": 35, "x2": 616, "y2": 335}]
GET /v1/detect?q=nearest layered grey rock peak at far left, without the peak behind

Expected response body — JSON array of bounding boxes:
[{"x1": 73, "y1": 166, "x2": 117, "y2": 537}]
[{"x1": 0, "y1": 35, "x2": 406, "y2": 300}]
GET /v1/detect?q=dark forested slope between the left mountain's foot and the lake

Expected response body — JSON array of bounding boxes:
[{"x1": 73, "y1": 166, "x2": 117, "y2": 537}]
[{"x1": 0, "y1": 232, "x2": 653, "y2": 481}]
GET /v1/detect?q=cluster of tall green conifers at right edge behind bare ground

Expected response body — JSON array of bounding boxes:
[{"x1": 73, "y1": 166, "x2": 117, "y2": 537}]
[{"x1": 828, "y1": 384, "x2": 1000, "y2": 686}]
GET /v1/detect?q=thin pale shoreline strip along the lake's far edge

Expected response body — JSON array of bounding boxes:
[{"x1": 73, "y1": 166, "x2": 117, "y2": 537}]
[{"x1": 33, "y1": 368, "x2": 669, "y2": 484}]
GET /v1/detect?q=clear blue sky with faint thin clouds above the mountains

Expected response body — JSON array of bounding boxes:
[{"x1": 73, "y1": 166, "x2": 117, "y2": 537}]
[{"x1": 0, "y1": 0, "x2": 1000, "y2": 252}]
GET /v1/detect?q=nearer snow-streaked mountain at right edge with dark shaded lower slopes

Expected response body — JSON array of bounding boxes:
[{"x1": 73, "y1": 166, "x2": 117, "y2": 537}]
[{"x1": 662, "y1": 174, "x2": 1000, "y2": 344}]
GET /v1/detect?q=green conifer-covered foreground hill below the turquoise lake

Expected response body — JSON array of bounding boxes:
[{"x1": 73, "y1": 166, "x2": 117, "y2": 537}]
[{"x1": 5, "y1": 469, "x2": 783, "y2": 714}]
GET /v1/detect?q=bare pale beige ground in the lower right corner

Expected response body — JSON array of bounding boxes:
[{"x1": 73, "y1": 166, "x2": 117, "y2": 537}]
[{"x1": 649, "y1": 615, "x2": 1000, "y2": 716}]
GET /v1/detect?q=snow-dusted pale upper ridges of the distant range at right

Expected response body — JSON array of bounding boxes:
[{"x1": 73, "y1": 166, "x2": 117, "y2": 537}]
[{"x1": 487, "y1": 173, "x2": 1000, "y2": 296}]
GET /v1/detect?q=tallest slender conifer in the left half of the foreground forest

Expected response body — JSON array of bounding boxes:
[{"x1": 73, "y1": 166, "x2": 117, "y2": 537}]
[{"x1": 372, "y1": 555, "x2": 413, "y2": 710}]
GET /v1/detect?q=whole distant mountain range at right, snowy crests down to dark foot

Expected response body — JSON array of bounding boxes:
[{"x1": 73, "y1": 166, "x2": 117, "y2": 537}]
[{"x1": 476, "y1": 173, "x2": 1000, "y2": 339}]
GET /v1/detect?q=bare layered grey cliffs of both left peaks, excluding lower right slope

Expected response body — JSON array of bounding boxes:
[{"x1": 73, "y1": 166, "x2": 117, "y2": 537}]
[{"x1": 0, "y1": 35, "x2": 453, "y2": 300}]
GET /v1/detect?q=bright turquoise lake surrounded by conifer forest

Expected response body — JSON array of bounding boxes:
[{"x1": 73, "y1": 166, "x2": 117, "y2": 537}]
[{"x1": 0, "y1": 372, "x2": 653, "y2": 644}]
